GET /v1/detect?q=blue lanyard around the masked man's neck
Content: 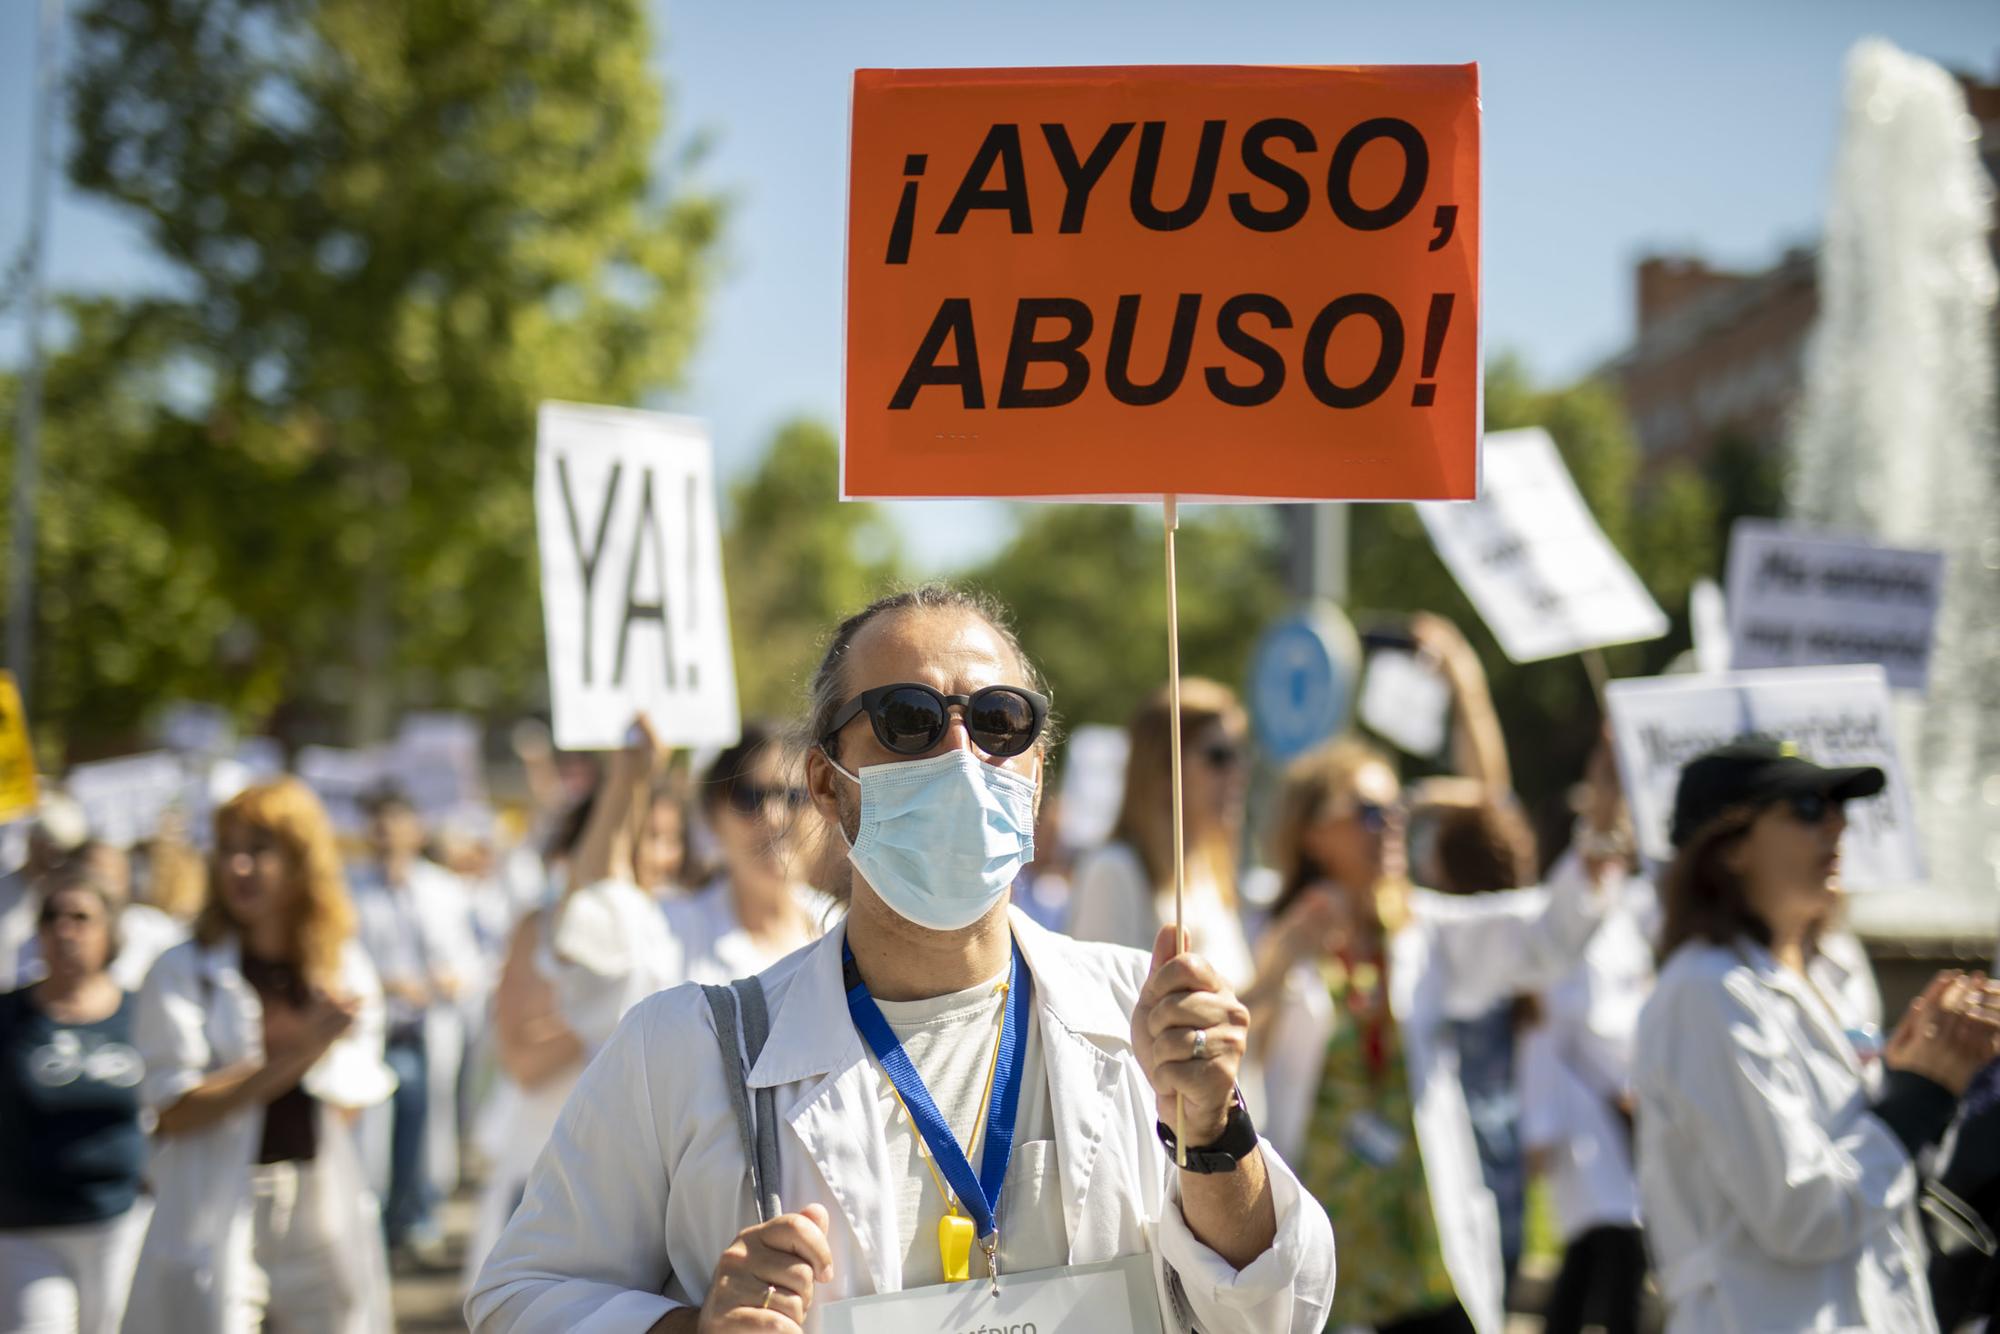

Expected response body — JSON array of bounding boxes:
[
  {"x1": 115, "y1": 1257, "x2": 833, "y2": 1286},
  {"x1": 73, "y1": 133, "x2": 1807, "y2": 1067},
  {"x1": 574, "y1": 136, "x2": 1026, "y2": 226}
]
[{"x1": 840, "y1": 942, "x2": 1034, "y2": 1236}]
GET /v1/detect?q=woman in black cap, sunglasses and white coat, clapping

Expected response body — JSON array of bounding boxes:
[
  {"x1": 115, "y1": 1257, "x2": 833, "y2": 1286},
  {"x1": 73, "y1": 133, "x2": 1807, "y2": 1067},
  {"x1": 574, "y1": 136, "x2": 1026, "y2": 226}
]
[{"x1": 1634, "y1": 740, "x2": 2000, "y2": 1332}]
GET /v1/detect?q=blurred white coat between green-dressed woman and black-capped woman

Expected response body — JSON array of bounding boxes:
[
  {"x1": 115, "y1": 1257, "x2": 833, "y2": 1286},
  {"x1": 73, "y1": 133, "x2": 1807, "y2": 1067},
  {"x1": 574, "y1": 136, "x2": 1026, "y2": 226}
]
[{"x1": 1516, "y1": 878, "x2": 1658, "y2": 1240}]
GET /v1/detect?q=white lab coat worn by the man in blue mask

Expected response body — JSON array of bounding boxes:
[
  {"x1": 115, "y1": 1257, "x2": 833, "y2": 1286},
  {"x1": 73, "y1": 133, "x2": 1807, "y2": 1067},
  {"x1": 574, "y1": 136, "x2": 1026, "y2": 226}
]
[{"x1": 466, "y1": 910, "x2": 1334, "y2": 1334}]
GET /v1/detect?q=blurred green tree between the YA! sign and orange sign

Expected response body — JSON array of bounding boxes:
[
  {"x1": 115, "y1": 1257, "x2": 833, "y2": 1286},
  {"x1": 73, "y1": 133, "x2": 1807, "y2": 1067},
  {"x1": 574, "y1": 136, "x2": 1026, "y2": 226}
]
[{"x1": 722, "y1": 420, "x2": 902, "y2": 718}]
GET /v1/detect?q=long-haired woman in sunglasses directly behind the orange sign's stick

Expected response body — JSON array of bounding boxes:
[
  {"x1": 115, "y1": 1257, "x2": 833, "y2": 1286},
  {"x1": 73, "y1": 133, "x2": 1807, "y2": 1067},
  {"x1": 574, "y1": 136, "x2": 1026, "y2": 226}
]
[{"x1": 1068, "y1": 676, "x2": 1256, "y2": 1000}]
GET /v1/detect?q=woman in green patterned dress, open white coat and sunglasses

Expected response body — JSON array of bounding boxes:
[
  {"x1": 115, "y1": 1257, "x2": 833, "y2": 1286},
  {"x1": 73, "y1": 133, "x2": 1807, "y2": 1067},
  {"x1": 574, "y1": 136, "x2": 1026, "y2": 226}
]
[{"x1": 1252, "y1": 740, "x2": 1600, "y2": 1334}]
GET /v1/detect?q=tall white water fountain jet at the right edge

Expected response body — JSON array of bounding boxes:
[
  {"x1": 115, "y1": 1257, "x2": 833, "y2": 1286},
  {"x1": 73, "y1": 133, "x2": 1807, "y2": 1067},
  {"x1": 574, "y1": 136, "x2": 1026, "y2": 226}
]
[{"x1": 1788, "y1": 38, "x2": 2000, "y2": 944}]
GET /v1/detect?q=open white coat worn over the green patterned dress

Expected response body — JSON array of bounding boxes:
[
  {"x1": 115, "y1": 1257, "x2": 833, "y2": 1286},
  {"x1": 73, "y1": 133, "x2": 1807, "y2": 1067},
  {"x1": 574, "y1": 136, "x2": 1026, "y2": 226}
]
[{"x1": 1264, "y1": 854, "x2": 1602, "y2": 1334}]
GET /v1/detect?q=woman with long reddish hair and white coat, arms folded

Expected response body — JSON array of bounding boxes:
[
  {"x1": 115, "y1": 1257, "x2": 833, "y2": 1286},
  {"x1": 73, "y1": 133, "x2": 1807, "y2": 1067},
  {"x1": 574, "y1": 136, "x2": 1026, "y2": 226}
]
[{"x1": 126, "y1": 778, "x2": 394, "y2": 1334}]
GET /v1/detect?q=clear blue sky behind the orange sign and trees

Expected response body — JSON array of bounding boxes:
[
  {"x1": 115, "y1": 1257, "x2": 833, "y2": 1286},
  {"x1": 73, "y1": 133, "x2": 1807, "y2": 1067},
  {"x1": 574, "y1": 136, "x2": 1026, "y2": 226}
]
[{"x1": 0, "y1": 0, "x2": 2000, "y2": 568}]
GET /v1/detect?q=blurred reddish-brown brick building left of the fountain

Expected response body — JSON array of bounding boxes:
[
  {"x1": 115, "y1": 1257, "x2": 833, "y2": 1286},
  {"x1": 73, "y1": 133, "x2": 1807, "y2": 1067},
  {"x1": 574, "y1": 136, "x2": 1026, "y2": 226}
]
[{"x1": 1604, "y1": 74, "x2": 2000, "y2": 470}]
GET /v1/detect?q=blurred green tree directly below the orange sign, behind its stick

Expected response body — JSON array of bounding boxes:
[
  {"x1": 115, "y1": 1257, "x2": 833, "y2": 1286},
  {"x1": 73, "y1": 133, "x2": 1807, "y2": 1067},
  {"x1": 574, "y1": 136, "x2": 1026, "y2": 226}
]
[{"x1": 964, "y1": 504, "x2": 1290, "y2": 724}]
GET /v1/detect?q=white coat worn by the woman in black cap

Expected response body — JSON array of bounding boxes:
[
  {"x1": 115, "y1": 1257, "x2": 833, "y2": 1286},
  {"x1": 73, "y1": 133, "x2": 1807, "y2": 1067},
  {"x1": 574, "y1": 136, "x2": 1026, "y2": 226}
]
[{"x1": 1634, "y1": 940, "x2": 1936, "y2": 1334}]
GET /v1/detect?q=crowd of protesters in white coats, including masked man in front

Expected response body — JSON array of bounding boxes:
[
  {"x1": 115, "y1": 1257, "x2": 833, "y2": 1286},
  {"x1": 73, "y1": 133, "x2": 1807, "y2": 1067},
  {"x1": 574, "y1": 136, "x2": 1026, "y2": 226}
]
[{"x1": 0, "y1": 588, "x2": 2000, "y2": 1334}]
